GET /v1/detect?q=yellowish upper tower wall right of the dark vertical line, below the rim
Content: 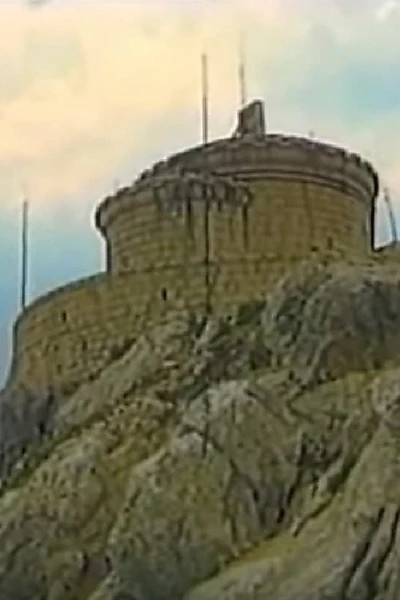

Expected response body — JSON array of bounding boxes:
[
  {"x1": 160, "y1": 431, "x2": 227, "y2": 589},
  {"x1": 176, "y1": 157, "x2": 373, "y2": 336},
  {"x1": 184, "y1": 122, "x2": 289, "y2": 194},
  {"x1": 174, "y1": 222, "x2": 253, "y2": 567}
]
[{"x1": 212, "y1": 180, "x2": 369, "y2": 263}]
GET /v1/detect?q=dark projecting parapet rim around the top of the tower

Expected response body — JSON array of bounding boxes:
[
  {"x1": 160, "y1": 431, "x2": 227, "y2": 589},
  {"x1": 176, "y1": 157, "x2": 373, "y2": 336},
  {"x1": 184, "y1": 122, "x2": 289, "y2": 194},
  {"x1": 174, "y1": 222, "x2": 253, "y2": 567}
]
[{"x1": 96, "y1": 134, "x2": 378, "y2": 233}]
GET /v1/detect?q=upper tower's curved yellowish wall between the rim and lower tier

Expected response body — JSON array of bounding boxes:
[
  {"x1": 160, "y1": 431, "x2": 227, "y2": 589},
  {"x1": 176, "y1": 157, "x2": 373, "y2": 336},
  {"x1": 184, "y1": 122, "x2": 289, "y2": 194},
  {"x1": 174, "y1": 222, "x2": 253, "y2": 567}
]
[{"x1": 97, "y1": 172, "x2": 370, "y2": 284}]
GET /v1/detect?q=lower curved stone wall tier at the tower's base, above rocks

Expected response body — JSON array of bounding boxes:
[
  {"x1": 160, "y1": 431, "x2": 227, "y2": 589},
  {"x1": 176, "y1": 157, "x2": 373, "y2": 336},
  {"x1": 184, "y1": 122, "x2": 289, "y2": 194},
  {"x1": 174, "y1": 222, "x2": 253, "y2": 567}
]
[{"x1": 9, "y1": 258, "x2": 306, "y2": 391}]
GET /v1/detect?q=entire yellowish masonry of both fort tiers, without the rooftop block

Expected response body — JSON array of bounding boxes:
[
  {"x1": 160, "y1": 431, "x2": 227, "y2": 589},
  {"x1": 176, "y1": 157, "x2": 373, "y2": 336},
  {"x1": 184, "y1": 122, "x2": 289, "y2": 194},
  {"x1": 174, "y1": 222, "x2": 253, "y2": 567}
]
[{"x1": 5, "y1": 102, "x2": 378, "y2": 389}]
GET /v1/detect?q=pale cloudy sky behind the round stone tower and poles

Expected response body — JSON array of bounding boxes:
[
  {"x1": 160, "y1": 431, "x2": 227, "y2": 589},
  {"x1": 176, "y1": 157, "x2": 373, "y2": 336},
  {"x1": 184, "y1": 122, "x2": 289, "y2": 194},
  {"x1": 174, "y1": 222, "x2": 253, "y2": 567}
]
[{"x1": 0, "y1": 0, "x2": 400, "y2": 383}]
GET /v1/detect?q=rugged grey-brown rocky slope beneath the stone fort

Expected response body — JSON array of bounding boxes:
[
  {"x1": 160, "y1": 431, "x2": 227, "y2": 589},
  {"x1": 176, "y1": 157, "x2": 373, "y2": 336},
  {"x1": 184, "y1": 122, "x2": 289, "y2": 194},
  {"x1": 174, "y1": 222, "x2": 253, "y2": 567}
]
[{"x1": 0, "y1": 266, "x2": 400, "y2": 600}]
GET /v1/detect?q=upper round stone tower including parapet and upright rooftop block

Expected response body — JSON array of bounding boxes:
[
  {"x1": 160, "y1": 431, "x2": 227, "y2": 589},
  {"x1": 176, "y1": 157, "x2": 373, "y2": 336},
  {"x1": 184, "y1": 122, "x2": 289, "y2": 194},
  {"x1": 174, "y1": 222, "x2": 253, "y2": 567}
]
[{"x1": 96, "y1": 101, "x2": 378, "y2": 296}]
